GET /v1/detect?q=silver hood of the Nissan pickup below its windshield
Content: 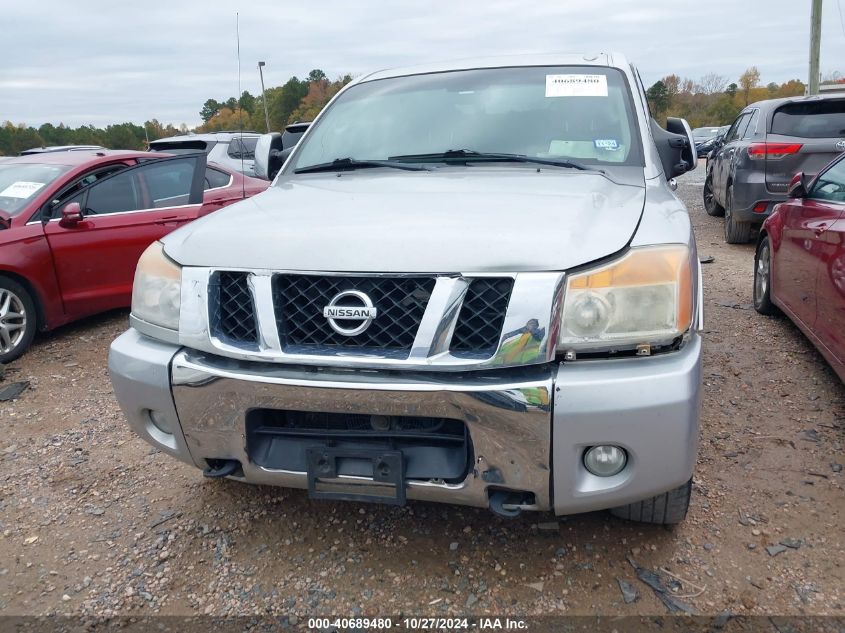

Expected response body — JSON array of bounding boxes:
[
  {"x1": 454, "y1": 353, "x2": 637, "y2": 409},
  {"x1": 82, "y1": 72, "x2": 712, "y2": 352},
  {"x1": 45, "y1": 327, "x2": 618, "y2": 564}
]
[{"x1": 164, "y1": 166, "x2": 645, "y2": 273}]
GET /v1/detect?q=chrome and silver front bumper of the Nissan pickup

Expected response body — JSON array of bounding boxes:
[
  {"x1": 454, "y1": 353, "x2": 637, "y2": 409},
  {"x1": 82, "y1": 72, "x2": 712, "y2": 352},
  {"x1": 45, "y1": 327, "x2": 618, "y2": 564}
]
[{"x1": 109, "y1": 330, "x2": 701, "y2": 514}]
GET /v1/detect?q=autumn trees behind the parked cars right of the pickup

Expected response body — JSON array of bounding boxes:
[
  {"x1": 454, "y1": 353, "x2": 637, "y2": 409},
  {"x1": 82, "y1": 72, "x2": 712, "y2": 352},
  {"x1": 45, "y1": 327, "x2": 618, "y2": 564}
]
[{"x1": 646, "y1": 66, "x2": 845, "y2": 127}]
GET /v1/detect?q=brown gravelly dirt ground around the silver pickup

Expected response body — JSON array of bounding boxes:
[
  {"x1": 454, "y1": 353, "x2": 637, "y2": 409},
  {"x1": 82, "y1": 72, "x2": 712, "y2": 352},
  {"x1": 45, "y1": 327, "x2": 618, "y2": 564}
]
[{"x1": 0, "y1": 169, "x2": 845, "y2": 621}]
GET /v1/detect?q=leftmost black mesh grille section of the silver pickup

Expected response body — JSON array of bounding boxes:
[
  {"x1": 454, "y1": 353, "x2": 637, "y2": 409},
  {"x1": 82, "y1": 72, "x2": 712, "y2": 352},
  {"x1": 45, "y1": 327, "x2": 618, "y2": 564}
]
[{"x1": 209, "y1": 271, "x2": 258, "y2": 344}]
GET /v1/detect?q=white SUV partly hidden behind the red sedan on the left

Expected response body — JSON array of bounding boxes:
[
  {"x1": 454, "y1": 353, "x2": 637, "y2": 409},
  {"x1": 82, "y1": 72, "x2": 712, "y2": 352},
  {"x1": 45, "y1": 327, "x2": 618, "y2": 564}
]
[{"x1": 150, "y1": 131, "x2": 260, "y2": 176}]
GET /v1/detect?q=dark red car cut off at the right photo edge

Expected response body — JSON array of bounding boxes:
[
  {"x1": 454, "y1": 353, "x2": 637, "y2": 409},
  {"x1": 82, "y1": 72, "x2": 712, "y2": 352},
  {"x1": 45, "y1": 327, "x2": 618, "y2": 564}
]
[{"x1": 754, "y1": 154, "x2": 845, "y2": 382}]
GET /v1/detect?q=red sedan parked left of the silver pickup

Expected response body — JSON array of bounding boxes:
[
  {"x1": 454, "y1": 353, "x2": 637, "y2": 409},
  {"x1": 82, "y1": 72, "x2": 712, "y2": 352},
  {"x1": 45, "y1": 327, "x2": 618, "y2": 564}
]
[{"x1": 0, "y1": 150, "x2": 270, "y2": 363}]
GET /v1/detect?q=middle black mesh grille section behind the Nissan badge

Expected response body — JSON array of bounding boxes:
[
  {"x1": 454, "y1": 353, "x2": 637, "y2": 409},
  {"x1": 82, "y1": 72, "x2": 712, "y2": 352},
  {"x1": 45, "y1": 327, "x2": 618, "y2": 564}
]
[{"x1": 273, "y1": 275, "x2": 435, "y2": 353}]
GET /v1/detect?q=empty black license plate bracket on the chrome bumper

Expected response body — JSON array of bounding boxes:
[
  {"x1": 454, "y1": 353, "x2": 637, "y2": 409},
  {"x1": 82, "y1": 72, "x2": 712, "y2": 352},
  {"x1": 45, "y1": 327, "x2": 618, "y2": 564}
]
[{"x1": 305, "y1": 447, "x2": 406, "y2": 506}]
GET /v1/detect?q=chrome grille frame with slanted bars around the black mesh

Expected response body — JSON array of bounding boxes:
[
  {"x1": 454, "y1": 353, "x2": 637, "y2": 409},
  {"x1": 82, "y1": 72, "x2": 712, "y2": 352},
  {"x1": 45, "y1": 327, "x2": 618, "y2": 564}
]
[{"x1": 179, "y1": 267, "x2": 564, "y2": 371}]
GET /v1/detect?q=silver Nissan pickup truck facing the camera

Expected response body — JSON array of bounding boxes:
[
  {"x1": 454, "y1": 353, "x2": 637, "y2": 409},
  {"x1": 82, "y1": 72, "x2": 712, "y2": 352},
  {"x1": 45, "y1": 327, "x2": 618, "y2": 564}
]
[{"x1": 109, "y1": 54, "x2": 702, "y2": 524}]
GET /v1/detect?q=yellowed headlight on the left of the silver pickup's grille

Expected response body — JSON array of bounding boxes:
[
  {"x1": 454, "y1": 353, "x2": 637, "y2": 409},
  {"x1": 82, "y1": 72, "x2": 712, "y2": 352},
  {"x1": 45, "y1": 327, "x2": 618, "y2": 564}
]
[{"x1": 132, "y1": 242, "x2": 182, "y2": 330}]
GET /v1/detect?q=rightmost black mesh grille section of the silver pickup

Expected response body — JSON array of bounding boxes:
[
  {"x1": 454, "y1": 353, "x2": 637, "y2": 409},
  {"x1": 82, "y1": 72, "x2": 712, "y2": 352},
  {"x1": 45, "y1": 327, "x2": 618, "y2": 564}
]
[{"x1": 450, "y1": 277, "x2": 513, "y2": 358}]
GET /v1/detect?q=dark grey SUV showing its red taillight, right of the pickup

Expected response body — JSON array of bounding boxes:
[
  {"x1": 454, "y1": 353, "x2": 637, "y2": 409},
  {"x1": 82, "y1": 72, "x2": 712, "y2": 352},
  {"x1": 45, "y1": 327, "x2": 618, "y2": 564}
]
[{"x1": 704, "y1": 95, "x2": 845, "y2": 244}]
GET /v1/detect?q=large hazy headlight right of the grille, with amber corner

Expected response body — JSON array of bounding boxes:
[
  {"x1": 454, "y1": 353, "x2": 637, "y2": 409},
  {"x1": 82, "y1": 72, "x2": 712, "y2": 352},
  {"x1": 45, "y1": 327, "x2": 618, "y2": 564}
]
[{"x1": 559, "y1": 245, "x2": 692, "y2": 351}]
